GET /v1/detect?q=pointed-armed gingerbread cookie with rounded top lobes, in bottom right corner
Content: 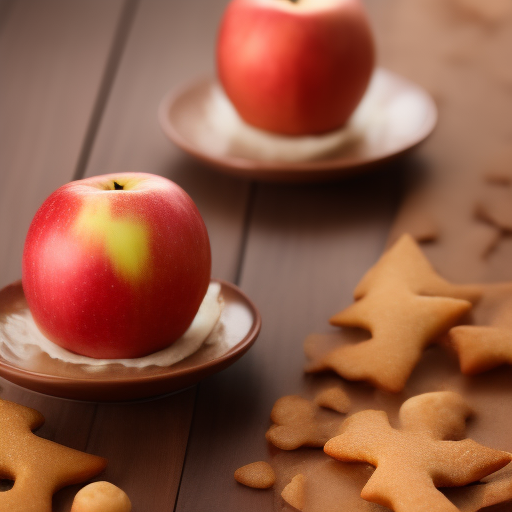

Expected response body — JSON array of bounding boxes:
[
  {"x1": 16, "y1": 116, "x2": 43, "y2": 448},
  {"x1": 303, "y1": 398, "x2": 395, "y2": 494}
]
[{"x1": 324, "y1": 392, "x2": 512, "y2": 512}]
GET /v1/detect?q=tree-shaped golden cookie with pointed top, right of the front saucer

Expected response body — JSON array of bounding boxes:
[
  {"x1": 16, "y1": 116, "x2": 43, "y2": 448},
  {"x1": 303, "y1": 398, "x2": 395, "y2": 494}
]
[{"x1": 306, "y1": 235, "x2": 480, "y2": 392}]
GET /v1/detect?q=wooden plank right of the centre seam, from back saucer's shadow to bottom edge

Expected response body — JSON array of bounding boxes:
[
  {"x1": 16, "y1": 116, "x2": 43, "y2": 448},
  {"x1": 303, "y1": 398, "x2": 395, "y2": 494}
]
[{"x1": 176, "y1": 169, "x2": 401, "y2": 512}]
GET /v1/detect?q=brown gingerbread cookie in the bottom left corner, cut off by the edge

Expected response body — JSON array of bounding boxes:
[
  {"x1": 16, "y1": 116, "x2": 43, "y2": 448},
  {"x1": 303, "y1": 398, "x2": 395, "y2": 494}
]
[{"x1": 0, "y1": 400, "x2": 107, "y2": 512}]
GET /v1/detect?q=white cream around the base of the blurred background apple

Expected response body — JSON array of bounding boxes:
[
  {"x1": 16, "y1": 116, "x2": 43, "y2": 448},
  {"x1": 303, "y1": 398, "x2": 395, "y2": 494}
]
[{"x1": 189, "y1": 68, "x2": 431, "y2": 163}]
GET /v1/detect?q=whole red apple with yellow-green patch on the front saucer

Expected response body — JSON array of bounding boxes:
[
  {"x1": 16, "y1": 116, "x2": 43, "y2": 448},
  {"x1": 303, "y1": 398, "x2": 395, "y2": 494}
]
[{"x1": 22, "y1": 173, "x2": 211, "y2": 359}]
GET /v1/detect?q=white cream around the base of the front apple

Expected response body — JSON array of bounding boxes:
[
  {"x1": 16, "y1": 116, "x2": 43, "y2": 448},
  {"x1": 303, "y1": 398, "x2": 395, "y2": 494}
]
[{"x1": 0, "y1": 283, "x2": 223, "y2": 371}]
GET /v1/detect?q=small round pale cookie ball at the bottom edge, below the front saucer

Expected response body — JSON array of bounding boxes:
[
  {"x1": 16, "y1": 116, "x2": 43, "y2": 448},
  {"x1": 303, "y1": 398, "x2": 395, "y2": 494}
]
[{"x1": 71, "y1": 482, "x2": 132, "y2": 512}]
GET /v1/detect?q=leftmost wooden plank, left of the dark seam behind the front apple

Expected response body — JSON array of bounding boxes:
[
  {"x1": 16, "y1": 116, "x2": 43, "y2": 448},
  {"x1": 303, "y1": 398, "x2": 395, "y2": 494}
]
[{"x1": 0, "y1": 0, "x2": 123, "y2": 511}]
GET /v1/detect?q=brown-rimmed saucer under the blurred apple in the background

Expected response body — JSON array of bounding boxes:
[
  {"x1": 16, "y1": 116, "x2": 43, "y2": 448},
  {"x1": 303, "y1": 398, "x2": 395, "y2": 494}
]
[{"x1": 158, "y1": 68, "x2": 437, "y2": 182}]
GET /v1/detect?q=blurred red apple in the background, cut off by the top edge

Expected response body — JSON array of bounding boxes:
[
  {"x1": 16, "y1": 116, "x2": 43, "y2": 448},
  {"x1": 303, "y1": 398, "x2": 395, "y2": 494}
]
[{"x1": 217, "y1": 0, "x2": 375, "y2": 135}]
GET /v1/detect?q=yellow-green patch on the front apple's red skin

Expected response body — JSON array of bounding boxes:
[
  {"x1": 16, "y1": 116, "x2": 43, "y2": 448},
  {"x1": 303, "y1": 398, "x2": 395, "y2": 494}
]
[{"x1": 74, "y1": 201, "x2": 149, "y2": 281}]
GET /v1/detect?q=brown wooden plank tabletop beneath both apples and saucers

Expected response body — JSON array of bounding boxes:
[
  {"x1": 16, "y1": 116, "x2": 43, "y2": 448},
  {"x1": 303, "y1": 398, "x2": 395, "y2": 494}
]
[{"x1": 0, "y1": 0, "x2": 508, "y2": 512}]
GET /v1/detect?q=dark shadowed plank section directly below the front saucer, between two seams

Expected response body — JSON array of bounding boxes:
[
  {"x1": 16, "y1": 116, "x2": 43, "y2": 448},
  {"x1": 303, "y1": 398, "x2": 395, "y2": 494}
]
[{"x1": 87, "y1": 389, "x2": 195, "y2": 512}]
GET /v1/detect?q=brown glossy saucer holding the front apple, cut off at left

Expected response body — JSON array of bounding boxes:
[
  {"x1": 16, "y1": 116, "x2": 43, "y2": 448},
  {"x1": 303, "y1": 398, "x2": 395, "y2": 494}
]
[{"x1": 0, "y1": 279, "x2": 261, "y2": 401}]
